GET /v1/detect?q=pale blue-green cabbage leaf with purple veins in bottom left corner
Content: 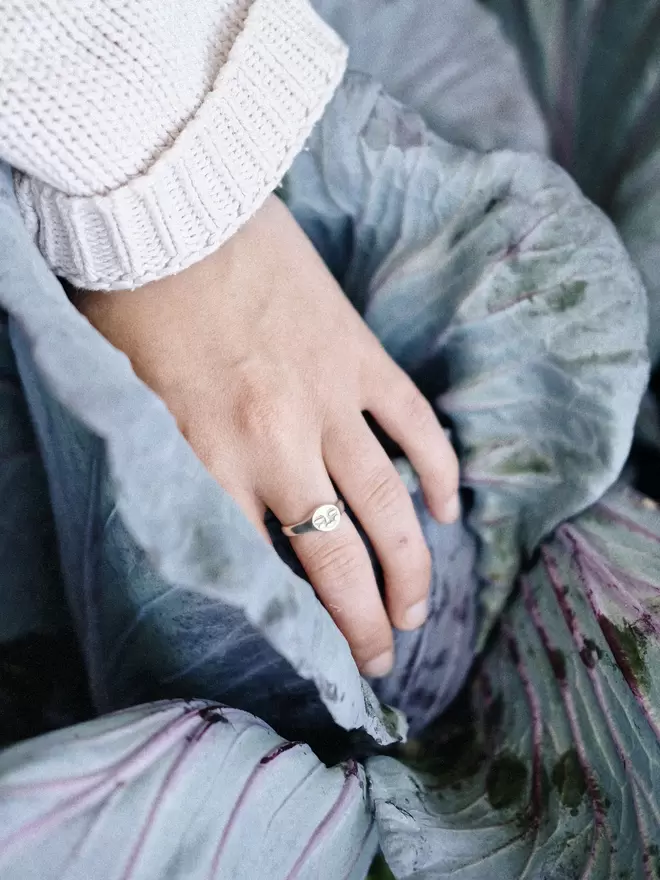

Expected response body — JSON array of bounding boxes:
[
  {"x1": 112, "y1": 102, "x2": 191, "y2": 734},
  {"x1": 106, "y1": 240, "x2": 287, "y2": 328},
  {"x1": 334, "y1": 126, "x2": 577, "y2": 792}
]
[{"x1": 0, "y1": 702, "x2": 376, "y2": 880}]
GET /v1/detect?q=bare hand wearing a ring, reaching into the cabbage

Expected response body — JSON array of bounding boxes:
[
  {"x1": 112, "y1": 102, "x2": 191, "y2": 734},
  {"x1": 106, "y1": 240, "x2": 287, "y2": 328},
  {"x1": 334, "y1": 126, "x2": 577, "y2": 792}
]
[{"x1": 77, "y1": 196, "x2": 459, "y2": 676}]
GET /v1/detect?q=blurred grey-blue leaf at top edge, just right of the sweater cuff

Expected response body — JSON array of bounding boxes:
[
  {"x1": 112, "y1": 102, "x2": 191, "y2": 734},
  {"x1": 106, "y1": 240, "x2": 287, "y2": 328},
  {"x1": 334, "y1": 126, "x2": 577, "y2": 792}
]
[{"x1": 313, "y1": 0, "x2": 548, "y2": 152}]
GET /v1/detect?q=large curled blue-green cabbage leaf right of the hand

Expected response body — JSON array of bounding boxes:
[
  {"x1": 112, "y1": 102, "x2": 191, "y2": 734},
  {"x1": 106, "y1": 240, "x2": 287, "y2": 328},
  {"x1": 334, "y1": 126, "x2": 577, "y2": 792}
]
[{"x1": 286, "y1": 76, "x2": 647, "y2": 633}]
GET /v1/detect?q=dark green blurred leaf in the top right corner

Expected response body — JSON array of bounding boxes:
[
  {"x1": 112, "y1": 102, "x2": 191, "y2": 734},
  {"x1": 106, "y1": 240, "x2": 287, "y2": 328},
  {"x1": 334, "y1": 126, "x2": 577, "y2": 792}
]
[{"x1": 482, "y1": 0, "x2": 660, "y2": 362}]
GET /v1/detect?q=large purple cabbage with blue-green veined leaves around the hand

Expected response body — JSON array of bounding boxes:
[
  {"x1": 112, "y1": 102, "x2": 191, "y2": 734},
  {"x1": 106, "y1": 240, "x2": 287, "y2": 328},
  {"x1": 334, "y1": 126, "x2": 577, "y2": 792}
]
[{"x1": 0, "y1": 0, "x2": 660, "y2": 880}]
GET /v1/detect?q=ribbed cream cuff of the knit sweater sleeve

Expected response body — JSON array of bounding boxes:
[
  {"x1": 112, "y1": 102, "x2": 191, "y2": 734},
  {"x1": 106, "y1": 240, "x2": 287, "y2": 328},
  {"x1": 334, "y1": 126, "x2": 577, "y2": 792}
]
[{"x1": 12, "y1": 0, "x2": 346, "y2": 290}]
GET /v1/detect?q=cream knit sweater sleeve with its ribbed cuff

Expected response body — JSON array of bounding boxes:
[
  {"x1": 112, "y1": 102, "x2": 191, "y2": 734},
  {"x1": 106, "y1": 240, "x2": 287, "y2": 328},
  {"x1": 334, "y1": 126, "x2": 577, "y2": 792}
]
[{"x1": 0, "y1": 0, "x2": 346, "y2": 289}]
